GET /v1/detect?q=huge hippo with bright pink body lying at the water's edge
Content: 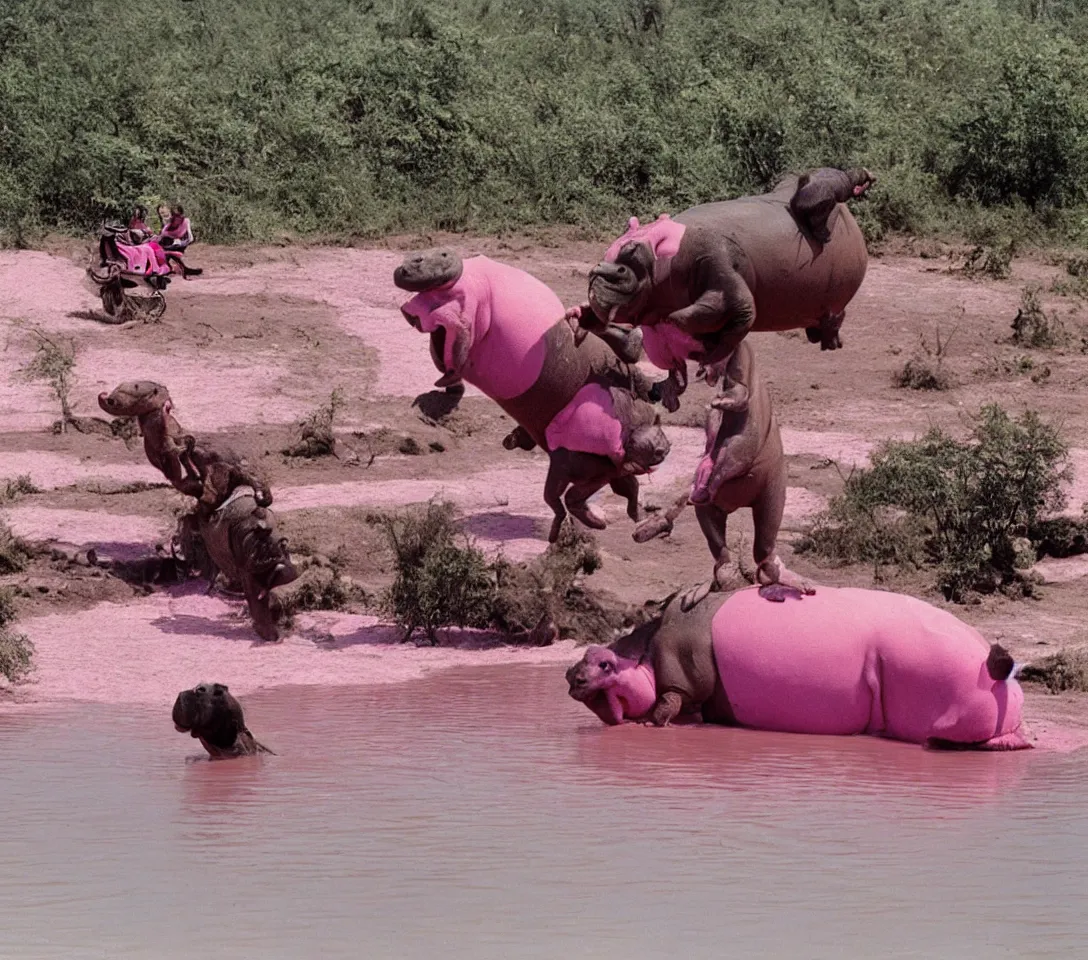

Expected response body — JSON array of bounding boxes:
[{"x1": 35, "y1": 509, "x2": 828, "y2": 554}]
[{"x1": 567, "y1": 587, "x2": 1030, "y2": 750}]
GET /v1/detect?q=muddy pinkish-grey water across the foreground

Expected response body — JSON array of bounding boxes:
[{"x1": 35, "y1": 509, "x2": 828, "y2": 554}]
[{"x1": 0, "y1": 667, "x2": 1088, "y2": 960}]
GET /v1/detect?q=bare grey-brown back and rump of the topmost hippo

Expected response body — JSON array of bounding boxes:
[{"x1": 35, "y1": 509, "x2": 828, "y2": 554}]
[{"x1": 676, "y1": 186, "x2": 868, "y2": 331}]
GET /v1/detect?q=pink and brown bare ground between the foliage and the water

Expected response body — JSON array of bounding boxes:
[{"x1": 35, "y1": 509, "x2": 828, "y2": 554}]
[{"x1": 0, "y1": 241, "x2": 1088, "y2": 747}]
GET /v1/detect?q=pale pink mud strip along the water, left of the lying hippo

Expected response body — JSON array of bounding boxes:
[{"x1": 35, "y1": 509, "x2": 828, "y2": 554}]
[{"x1": 0, "y1": 584, "x2": 578, "y2": 706}]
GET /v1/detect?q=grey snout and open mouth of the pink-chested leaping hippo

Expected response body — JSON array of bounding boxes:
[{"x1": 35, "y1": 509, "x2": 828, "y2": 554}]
[{"x1": 393, "y1": 249, "x2": 475, "y2": 386}]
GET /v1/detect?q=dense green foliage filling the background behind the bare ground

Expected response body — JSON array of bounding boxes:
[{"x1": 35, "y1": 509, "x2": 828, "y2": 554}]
[{"x1": 0, "y1": 0, "x2": 1088, "y2": 243}]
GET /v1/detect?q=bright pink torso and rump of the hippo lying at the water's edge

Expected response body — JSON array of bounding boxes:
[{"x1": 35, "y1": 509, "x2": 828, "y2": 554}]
[{"x1": 713, "y1": 587, "x2": 1023, "y2": 743}]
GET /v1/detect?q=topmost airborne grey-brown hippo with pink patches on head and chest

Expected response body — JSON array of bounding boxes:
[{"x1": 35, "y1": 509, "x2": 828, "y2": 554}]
[{"x1": 567, "y1": 169, "x2": 868, "y2": 407}]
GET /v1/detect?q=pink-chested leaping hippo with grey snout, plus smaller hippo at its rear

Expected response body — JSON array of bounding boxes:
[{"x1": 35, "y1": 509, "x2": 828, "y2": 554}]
[{"x1": 394, "y1": 249, "x2": 668, "y2": 531}]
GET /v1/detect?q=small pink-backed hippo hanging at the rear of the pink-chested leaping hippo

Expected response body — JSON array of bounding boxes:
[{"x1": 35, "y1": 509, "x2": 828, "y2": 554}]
[{"x1": 530, "y1": 383, "x2": 669, "y2": 543}]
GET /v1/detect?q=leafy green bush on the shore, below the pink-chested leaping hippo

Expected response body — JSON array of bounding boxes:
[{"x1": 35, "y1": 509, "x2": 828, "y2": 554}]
[{"x1": 382, "y1": 501, "x2": 495, "y2": 643}]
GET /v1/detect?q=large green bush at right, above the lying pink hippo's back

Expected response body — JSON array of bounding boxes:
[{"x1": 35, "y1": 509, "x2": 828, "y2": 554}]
[{"x1": 800, "y1": 405, "x2": 1072, "y2": 600}]
